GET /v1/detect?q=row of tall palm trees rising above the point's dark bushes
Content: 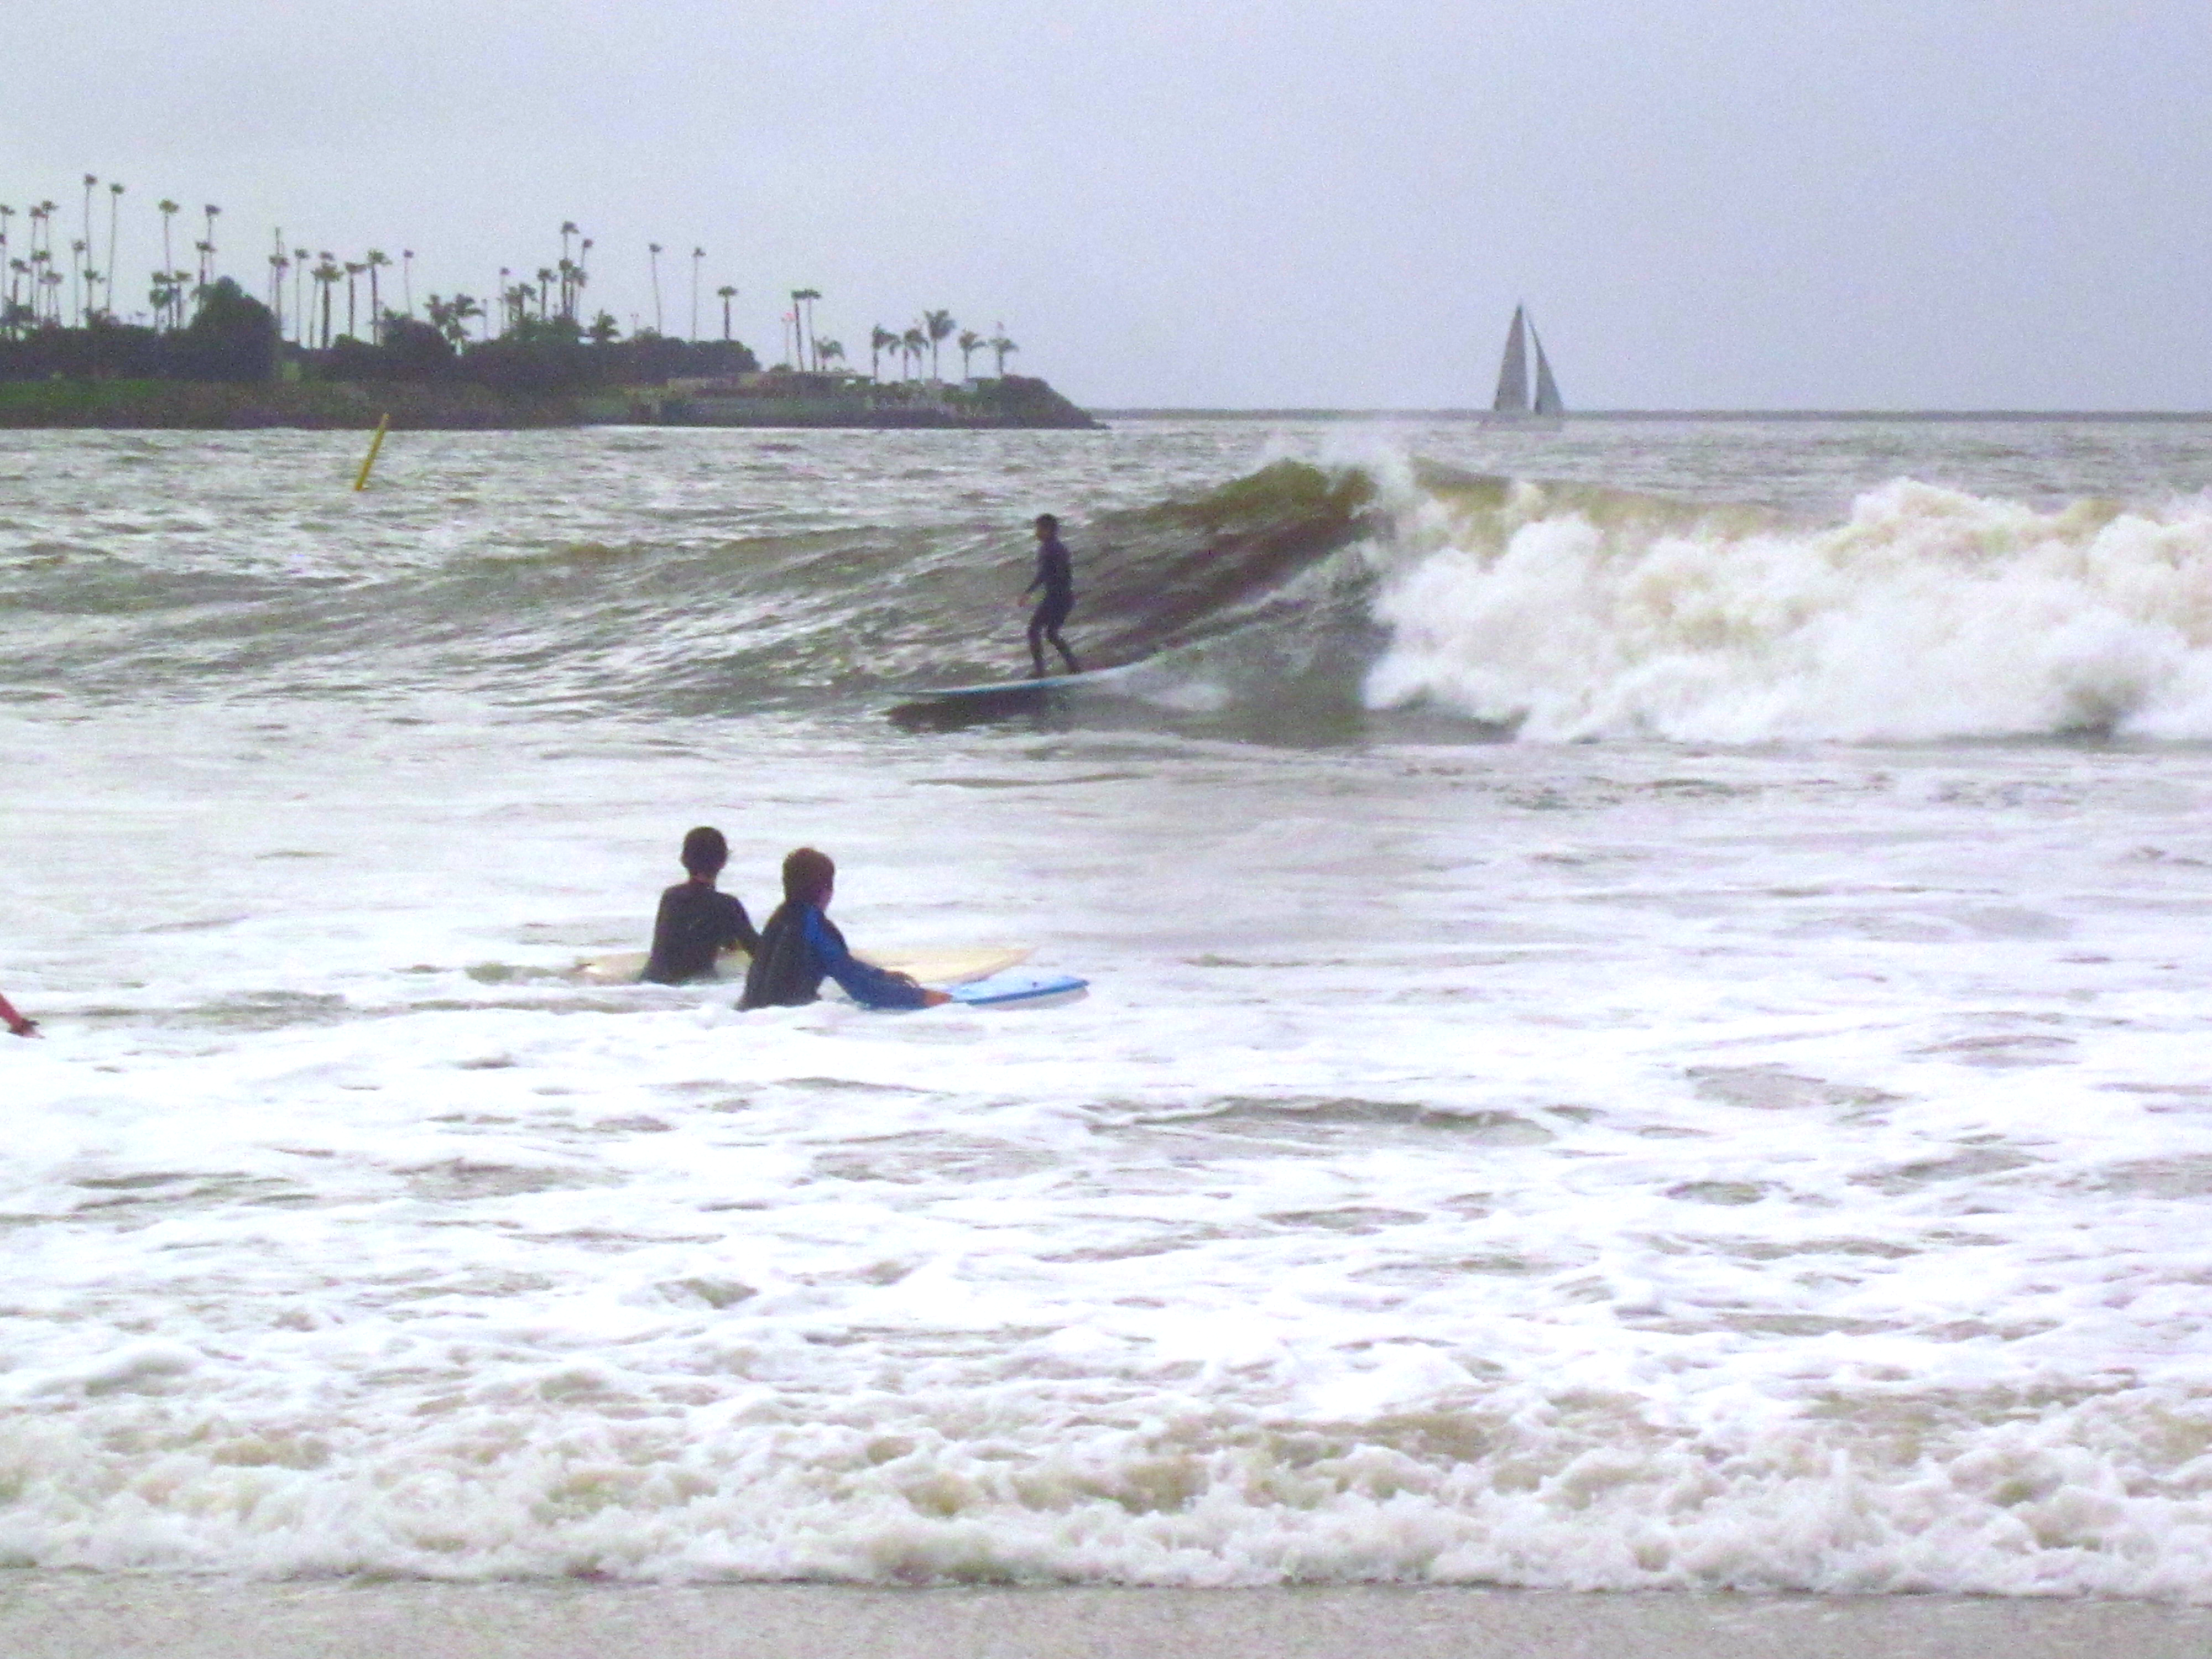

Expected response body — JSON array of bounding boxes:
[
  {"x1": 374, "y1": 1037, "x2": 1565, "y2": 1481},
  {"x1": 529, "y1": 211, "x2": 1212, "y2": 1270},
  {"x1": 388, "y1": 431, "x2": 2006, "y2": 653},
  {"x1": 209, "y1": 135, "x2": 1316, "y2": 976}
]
[{"x1": 0, "y1": 189, "x2": 1020, "y2": 378}]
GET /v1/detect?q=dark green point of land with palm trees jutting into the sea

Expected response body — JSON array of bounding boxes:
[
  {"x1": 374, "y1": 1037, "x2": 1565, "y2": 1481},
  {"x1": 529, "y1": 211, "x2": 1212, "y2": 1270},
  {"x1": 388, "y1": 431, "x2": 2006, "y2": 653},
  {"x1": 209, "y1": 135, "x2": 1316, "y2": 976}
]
[{"x1": 0, "y1": 185, "x2": 1097, "y2": 427}]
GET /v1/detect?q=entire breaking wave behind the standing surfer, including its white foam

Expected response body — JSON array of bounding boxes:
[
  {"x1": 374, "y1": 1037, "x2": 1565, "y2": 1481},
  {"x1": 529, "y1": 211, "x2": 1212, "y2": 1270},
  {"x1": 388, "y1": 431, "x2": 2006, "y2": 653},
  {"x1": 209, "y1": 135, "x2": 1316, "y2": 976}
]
[{"x1": 13, "y1": 429, "x2": 2212, "y2": 743}]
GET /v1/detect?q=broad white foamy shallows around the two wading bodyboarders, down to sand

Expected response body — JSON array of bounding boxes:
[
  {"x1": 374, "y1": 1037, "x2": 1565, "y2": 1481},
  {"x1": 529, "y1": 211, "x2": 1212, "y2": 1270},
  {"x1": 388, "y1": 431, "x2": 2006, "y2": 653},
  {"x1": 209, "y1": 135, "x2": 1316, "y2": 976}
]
[{"x1": 0, "y1": 425, "x2": 2212, "y2": 1601}]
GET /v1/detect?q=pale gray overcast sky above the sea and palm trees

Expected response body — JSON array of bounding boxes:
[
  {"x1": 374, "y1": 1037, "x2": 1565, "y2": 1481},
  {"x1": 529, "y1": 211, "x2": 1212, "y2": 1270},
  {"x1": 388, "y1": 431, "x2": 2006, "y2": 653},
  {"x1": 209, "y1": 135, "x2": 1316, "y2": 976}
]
[{"x1": 0, "y1": 0, "x2": 2212, "y2": 409}]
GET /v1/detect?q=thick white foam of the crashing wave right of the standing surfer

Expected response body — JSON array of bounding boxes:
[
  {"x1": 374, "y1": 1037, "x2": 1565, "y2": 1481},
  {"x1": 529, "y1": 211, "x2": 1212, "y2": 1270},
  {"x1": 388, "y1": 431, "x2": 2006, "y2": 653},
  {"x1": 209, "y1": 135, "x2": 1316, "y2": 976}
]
[{"x1": 1367, "y1": 482, "x2": 2212, "y2": 743}]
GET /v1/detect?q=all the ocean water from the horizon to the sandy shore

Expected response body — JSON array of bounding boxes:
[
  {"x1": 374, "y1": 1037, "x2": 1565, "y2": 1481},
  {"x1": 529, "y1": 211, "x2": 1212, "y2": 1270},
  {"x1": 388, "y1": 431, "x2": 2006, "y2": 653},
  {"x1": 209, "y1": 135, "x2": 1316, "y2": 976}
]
[{"x1": 0, "y1": 420, "x2": 2212, "y2": 1601}]
